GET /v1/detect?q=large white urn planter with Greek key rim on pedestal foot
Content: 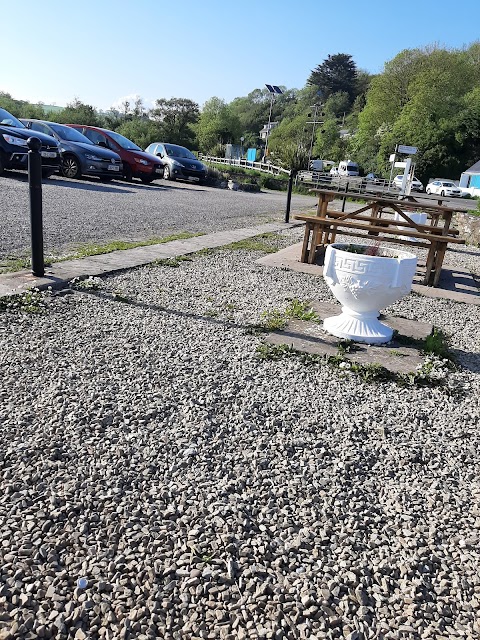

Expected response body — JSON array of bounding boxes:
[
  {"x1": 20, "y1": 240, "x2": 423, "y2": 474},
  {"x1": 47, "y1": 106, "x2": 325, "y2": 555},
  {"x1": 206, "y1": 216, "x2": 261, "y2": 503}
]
[{"x1": 323, "y1": 244, "x2": 417, "y2": 344}]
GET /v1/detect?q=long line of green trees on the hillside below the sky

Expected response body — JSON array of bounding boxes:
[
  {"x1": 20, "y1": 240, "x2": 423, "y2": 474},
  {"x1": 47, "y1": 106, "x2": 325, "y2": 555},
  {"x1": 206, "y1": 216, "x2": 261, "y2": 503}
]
[{"x1": 0, "y1": 42, "x2": 480, "y2": 180}]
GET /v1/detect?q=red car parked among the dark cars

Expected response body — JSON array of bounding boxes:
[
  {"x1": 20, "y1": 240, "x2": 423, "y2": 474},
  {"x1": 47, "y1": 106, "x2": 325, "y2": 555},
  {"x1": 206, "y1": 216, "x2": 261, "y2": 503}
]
[{"x1": 68, "y1": 124, "x2": 163, "y2": 184}]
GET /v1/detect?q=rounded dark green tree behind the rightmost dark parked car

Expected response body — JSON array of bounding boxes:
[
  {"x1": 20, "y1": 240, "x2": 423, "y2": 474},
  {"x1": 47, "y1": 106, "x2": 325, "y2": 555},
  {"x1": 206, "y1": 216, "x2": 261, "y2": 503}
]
[{"x1": 150, "y1": 98, "x2": 200, "y2": 148}]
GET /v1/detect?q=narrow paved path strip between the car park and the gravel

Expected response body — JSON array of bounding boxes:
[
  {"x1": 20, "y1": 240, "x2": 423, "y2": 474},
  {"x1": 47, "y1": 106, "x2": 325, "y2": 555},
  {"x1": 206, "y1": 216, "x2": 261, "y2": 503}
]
[{"x1": 0, "y1": 223, "x2": 301, "y2": 296}]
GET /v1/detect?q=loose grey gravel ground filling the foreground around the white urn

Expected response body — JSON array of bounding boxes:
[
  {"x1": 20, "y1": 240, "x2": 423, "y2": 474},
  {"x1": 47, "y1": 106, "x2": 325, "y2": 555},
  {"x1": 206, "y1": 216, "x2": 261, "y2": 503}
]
[{"x1": 0, "y1": 229, "x2": 480, "y2": 640}]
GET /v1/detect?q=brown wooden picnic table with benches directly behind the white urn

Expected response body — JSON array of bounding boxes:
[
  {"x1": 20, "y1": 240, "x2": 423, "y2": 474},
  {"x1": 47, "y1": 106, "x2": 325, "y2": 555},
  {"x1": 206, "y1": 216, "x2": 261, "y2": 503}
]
[{"x1": 294, "y1": 189, "x2": 465, "y2": 287}]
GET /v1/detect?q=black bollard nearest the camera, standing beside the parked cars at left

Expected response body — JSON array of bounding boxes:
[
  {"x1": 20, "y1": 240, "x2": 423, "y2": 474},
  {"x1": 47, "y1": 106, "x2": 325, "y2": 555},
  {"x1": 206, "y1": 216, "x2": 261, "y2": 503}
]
[{"x1": 27, "y1": 137, "x2": 45, "y2": 278}]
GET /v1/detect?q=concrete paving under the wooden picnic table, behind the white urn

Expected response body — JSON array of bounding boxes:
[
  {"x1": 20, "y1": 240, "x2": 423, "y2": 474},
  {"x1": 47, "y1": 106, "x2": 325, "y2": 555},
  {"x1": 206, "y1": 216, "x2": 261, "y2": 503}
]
[{"x1": 257, "y1": 242, "x2": 480, "y2": 305}]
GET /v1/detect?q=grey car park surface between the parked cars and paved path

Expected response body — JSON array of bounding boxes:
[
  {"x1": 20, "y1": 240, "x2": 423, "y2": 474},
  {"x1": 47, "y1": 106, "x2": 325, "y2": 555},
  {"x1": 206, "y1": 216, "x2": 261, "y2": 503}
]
[{"x1": 0, "y1": 171, "x2": 315, "y2": 261}]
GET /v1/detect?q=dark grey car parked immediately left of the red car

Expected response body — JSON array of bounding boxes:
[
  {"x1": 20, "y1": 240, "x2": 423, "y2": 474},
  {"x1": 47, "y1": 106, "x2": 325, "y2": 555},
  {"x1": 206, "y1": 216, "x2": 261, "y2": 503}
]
[{"x1": 22, "y1": 118, "x2": 123, "y2": 181}]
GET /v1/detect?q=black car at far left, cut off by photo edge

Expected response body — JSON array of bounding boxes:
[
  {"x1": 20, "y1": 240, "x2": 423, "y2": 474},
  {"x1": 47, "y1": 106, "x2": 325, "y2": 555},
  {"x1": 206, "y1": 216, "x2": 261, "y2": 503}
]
[{"x1": 0, "y1": 109, "x2": 61, "y2": 178}]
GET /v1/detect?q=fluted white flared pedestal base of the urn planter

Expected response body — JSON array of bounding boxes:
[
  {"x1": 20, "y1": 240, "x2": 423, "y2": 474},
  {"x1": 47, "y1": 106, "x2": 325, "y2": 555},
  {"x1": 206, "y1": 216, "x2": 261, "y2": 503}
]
[{"x1": 323, "y1": 307, "x2": 393, "y2": 344}]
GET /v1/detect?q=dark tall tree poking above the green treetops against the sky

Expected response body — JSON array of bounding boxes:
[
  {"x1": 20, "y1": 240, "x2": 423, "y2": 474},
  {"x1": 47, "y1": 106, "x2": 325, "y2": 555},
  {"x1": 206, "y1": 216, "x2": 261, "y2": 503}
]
[{"x1": 307, "y1": 53, "x2": 357, "y2": 102}]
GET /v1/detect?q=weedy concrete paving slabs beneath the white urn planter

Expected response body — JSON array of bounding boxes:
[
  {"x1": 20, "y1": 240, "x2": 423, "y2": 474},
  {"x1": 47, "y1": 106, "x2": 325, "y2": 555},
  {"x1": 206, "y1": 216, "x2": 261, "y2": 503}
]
[{"x1": 265, "y1": 301, "x2": 433, "y2": 374}]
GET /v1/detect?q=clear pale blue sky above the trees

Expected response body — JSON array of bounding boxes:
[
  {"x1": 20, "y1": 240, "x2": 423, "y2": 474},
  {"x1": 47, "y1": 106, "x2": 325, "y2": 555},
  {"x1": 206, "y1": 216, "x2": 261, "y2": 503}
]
[{"x1": 0, "y1": 0, "x2": 480, "y2": 109}]
